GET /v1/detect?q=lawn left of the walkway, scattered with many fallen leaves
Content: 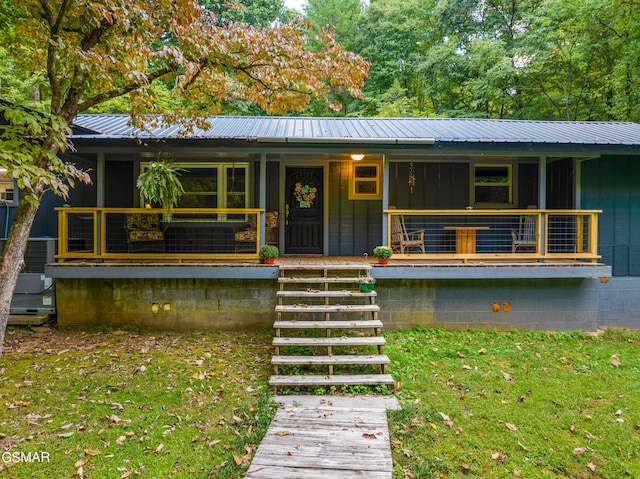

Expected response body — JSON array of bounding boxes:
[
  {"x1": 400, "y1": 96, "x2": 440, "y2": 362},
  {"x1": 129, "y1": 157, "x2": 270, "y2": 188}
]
[{"x1": 0, "y1": 330, "x2": 274, "y2": 478}]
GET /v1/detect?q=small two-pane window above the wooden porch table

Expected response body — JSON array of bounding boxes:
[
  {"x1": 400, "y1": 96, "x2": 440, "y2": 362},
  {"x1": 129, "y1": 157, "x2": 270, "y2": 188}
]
[{"x1": 473, "y1": 165, "x2": 513, "y2": 206}]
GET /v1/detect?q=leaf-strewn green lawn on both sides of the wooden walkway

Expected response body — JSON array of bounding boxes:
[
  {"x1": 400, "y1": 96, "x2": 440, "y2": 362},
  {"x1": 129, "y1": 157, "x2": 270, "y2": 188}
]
[{"x1": 0, "y1": 329, "x2": 640, "y2": 479}]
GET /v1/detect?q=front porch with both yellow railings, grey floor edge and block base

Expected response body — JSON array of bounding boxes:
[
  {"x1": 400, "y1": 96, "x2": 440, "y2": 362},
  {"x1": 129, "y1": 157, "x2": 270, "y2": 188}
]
[{"x1": 50, "y1": 208, "x2": 611, "y2": 331}]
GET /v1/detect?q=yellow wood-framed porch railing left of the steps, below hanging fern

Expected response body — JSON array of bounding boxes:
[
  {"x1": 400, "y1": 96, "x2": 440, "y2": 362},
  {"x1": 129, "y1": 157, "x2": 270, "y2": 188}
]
[{"x1": 56, "y1": 207, "x2": 264, "y2": 260}]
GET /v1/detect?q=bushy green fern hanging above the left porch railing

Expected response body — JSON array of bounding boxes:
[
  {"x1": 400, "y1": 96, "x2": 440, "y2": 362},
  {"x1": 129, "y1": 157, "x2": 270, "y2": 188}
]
[{"x1": 136, "y1": 156, "x2": 186, "y2": 221}]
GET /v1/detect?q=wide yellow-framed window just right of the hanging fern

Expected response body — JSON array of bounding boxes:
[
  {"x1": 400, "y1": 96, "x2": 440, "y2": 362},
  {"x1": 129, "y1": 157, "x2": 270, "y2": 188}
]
[{"x1": 142, "y1": 162, "x2": 249, "y2": 208}]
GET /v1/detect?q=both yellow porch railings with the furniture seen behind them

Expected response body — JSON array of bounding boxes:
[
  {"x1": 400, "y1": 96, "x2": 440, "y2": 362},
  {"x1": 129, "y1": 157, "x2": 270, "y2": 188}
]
[{"x1": 56, "y1": 207, "x2": 605, "y2": 277}]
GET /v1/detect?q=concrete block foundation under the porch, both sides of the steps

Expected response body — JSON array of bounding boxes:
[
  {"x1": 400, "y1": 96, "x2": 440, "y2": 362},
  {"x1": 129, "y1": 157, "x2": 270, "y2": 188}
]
[{"x1": 56, "y1": 278, "x2": 602, "y2": 331}]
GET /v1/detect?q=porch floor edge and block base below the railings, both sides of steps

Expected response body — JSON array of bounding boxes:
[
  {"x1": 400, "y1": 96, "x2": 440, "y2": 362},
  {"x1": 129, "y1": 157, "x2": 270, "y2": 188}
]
[{"x1": 46, "y1": 257, "x2": 610, "y2": 331}]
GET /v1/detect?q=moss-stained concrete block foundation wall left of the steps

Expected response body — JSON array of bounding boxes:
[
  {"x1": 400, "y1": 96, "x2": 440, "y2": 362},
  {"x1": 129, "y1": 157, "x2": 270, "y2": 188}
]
[{"x1": 56, "y1": 278, "x2": 278, "y2": 330}]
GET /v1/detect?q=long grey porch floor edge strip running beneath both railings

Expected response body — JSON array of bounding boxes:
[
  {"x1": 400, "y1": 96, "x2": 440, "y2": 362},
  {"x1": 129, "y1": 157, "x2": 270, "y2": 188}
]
[{"x1": 45, "y1": 255, "x2": 611, "y2": 279}]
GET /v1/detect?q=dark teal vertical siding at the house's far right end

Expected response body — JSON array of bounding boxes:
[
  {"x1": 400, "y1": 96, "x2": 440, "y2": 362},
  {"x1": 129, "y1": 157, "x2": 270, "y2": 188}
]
[{"x1": 581, "y1": 156, "x2": 640, "y2": 276}]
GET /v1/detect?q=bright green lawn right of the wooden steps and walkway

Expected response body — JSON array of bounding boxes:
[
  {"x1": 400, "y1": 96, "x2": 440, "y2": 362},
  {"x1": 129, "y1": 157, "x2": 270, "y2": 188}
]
[{"x1": 387, "y1": 330, "x2": 640, "y2": 479}]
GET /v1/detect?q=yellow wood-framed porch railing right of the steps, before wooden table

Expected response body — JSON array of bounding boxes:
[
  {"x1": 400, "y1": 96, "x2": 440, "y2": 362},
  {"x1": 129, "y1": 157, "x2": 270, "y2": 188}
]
[{"x1": 384, "y1": 209, "x2": 601, "y2": 262}]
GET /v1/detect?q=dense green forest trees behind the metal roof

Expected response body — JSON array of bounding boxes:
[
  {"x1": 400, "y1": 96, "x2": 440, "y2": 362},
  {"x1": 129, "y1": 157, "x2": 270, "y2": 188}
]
[{"x1": 0, "y1": 0, "x2": 640, "y2": 122}]
